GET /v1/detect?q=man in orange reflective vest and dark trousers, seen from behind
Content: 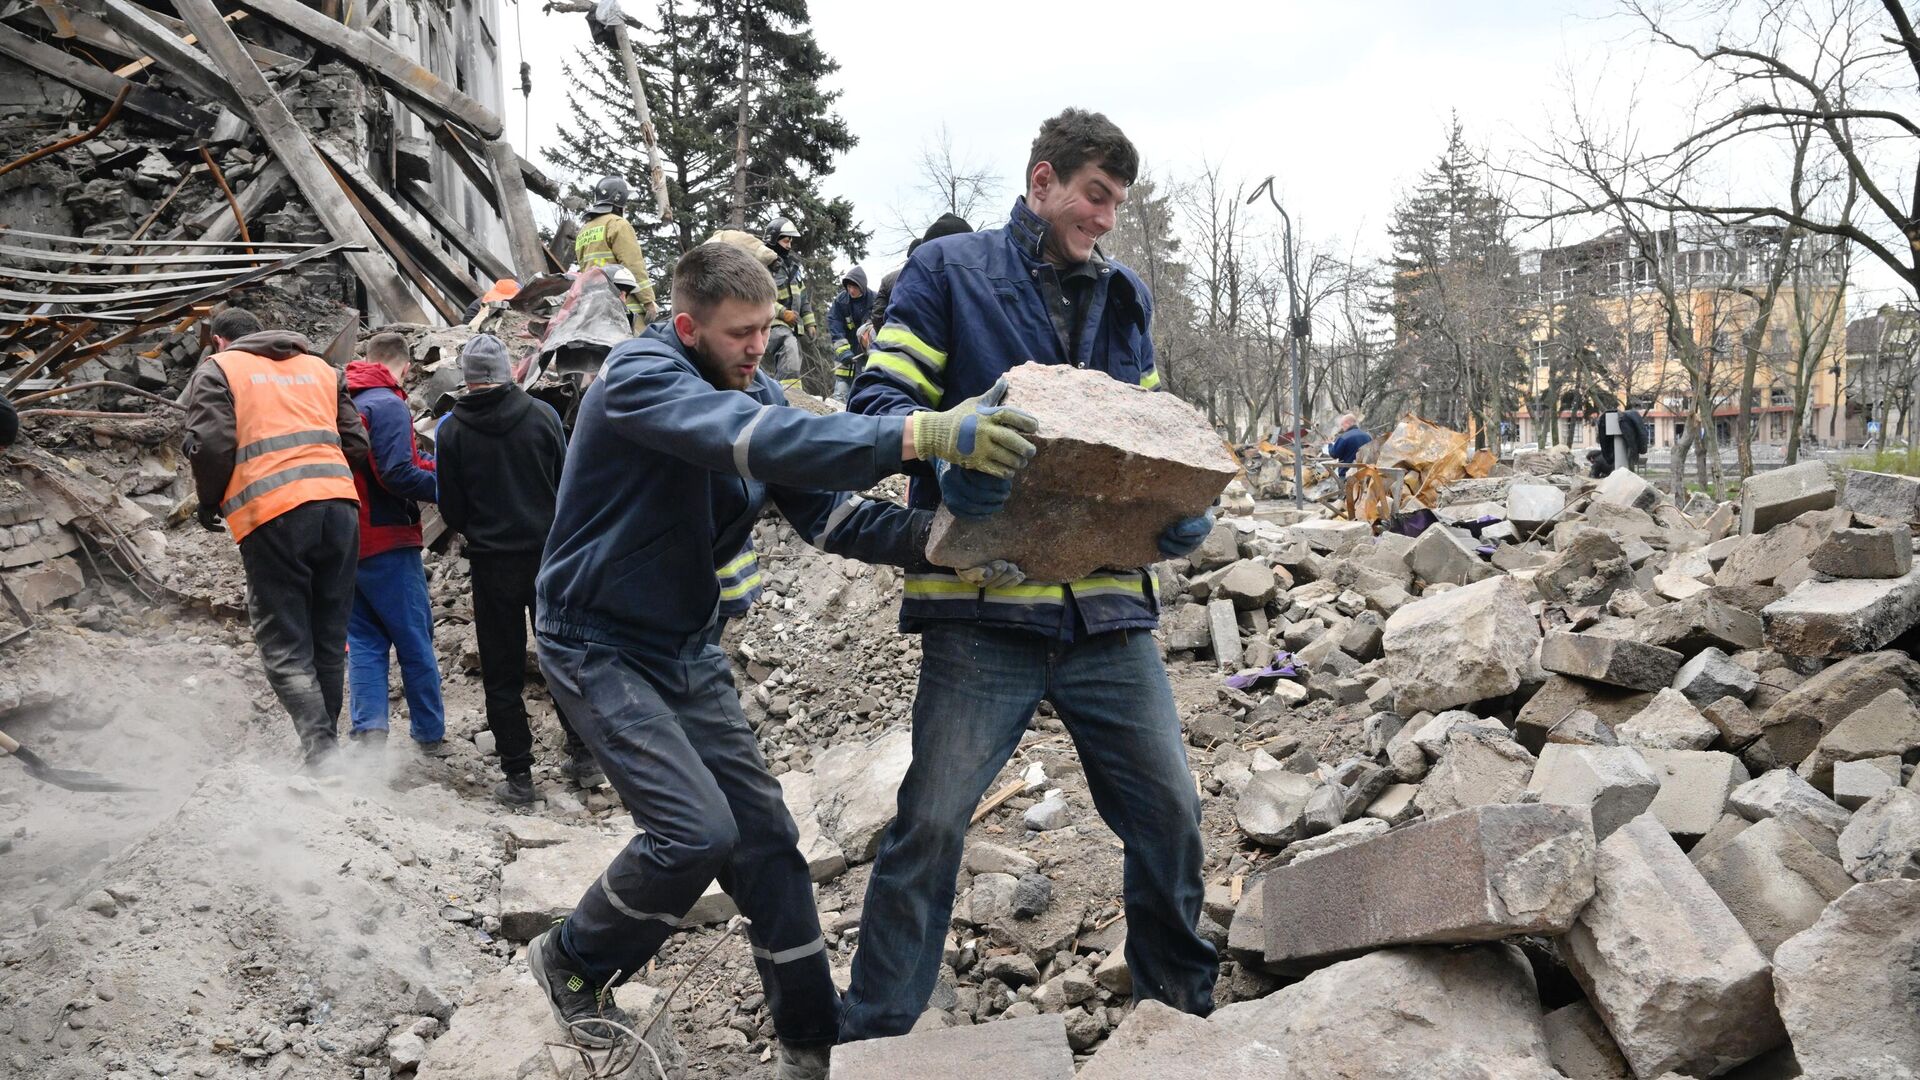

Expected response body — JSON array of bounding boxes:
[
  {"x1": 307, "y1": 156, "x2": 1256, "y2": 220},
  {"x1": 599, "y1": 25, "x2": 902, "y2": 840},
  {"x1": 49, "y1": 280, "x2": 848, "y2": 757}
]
[{"x1": 180, "y1": 307, "x2": 367, "y2": 769}]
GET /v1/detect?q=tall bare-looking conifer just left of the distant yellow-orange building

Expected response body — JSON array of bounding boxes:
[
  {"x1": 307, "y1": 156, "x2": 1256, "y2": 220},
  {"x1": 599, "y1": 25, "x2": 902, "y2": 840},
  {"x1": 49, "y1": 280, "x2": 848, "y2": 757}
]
[{"x1": 1386, "y1": 117, "x2": 1526, "y2": 446}]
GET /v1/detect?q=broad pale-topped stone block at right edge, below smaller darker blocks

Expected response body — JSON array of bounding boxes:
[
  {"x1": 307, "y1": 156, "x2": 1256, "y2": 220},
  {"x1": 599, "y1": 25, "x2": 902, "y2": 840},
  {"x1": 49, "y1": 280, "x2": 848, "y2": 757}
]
[{"x1": 1761, "y1": 567, "x2": 1920, "y2": 657}]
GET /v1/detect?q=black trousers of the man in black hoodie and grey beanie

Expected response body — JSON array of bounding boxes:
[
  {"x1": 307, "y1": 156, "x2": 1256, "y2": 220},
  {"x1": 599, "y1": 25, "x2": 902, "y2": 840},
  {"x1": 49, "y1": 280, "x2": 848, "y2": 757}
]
[{"x1": 467, "y1": 552, "x2": 588, "y2": 776}]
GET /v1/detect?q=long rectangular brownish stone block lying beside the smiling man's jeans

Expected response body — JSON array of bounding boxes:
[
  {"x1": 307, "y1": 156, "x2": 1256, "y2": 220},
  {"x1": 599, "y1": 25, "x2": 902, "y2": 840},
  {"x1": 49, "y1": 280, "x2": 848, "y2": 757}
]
[{"x1": 1261, "y1": 803, "x2": 1594, "y2": 970}]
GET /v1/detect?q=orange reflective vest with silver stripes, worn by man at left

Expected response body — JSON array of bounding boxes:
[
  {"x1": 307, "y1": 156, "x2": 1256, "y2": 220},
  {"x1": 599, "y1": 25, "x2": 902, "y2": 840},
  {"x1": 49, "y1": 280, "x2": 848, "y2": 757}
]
[{"x1": 213, "y1": 352, "x2": 359, "y2": 542}]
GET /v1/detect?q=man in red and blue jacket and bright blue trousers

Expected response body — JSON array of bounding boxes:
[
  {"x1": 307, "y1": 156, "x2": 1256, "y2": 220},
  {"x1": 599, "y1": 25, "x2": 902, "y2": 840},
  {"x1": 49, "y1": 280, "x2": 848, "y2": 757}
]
[{"x1": 348, "y1": 332, "x2": 447, "y2": 753}]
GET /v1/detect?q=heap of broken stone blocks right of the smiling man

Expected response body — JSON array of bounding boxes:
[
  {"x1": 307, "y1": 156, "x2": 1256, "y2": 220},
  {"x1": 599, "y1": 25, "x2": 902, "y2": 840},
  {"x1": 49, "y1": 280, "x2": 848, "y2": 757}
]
[{"x1": 833, "y1": 455, "x2": 1920, "y2": 1080}]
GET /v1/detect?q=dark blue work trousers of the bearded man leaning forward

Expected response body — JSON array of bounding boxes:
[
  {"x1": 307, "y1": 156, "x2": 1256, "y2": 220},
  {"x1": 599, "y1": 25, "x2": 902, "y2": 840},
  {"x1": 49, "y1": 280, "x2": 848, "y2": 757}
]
[{"x1": 534, "y1": 632, "x2": 839, "y2": 1045}]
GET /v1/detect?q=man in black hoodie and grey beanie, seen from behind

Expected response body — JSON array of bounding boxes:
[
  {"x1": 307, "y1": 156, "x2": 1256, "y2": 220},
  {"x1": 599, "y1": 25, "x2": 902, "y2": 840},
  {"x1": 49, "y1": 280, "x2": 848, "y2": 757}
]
[{"x1": 434, "y1": 334, "x2": 607, "y2": 805}]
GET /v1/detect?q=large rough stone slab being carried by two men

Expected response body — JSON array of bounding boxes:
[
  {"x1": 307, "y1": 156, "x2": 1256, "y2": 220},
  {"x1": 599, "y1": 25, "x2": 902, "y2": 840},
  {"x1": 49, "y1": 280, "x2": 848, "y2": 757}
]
[{"x1": 927, "y1": 363, "x2": 1240, "y2": 582}]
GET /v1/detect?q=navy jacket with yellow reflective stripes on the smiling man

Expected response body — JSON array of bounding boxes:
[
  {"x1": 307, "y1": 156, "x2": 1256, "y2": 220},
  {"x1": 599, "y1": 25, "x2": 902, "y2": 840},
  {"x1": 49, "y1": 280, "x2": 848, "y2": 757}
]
[{"x1": 849, "y1": 200, "x2": 1160, "y2": 640}]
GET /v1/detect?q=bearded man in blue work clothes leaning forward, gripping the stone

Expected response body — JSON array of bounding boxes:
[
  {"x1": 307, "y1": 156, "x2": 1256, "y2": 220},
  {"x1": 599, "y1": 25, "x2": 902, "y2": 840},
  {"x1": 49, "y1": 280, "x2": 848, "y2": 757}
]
[{"x1": 528, "y1": 244, "x2": 1033, "y2": 1080}]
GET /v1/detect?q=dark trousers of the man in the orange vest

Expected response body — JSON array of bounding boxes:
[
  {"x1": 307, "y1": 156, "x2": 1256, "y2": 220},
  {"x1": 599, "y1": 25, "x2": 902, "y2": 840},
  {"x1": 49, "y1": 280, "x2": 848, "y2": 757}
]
[{"x1": 240, "y1": 500, "x2": 359, "y2": 763}]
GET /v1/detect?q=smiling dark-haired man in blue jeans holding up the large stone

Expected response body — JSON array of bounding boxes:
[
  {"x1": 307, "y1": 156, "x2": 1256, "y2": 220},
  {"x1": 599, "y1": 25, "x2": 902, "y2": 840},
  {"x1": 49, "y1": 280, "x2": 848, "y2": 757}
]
[{"x1": 841, "y1": 110, "x2": 1217, "y2": 1042}]
